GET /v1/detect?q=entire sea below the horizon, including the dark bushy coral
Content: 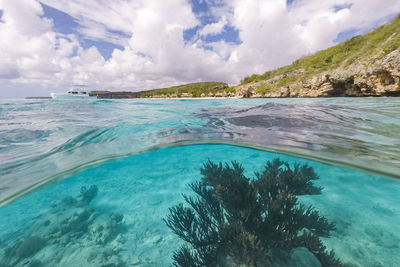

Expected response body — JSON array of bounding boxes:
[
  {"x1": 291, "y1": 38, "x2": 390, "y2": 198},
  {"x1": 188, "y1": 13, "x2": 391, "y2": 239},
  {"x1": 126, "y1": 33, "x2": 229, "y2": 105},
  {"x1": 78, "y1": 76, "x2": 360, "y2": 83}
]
[{"x1": 0, "y1": 98, "x2": 400, "y2": 267}]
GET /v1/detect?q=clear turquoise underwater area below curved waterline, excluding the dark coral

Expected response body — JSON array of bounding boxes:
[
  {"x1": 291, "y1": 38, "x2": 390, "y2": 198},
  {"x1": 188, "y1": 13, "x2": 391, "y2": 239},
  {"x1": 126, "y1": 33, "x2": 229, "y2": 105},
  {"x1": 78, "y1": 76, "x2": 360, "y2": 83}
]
[{"x1": 0, "y1": 145, "x2": 400, "y2": 266}]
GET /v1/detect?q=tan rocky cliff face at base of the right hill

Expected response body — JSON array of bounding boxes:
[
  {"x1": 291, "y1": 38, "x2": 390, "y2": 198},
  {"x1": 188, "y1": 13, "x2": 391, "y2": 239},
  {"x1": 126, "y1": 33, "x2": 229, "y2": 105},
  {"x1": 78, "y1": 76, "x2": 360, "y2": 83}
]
[{"x1": 236, "y1": 49, "x2": 400, "y2": 97}]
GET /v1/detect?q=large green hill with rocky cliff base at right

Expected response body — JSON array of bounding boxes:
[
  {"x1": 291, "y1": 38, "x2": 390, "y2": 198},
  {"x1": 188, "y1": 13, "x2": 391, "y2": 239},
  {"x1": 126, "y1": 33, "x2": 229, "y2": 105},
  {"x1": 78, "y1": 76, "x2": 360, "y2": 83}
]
[{"x1": 236, "y1": 15, "x2": 400, "y2": 97}]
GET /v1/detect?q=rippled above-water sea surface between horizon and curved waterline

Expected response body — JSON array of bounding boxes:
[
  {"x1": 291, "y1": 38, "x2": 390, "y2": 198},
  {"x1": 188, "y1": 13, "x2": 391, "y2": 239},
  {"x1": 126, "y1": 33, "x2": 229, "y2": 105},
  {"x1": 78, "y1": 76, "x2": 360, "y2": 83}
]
[{"x1": 0, "y1": 98, "x2": 400, "y2": 202}]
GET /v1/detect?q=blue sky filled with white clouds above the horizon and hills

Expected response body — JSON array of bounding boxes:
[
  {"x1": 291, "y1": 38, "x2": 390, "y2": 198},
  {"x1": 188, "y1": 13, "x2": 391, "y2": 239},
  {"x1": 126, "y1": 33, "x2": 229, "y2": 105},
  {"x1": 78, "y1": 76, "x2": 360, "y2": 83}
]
[{"x1": 0, "y1": 0, "x2": 400, "y2": 98}]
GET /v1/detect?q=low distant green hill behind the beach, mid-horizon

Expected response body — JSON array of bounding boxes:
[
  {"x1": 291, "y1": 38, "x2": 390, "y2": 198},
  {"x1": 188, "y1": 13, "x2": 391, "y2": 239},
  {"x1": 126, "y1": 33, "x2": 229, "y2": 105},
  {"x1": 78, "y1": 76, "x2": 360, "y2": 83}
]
[{"x1": 138, "y1": 82, "x2": 231, "y2": 97}]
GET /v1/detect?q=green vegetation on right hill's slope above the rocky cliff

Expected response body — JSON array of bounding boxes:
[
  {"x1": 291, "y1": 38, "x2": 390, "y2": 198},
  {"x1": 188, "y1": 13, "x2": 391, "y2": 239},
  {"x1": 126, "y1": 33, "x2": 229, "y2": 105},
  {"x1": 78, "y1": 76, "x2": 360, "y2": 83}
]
[{"x1": 241, "y1": 15, "x2": 400, "y2": 93}]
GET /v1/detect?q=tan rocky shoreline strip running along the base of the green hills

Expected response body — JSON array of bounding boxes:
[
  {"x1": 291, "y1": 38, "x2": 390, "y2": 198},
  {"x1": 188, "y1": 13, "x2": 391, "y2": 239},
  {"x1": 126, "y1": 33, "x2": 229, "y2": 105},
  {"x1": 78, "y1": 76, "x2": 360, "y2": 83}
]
[{"x1": 27, "y1": 48, "x2": 400, "y2": 99}]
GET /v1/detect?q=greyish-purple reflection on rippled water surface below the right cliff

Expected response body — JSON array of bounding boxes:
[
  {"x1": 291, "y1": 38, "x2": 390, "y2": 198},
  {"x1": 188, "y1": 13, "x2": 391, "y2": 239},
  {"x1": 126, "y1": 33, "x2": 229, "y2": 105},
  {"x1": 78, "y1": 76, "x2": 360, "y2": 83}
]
[{"x1": 188, "y1": 102, "x2": 400, "y2": 177}]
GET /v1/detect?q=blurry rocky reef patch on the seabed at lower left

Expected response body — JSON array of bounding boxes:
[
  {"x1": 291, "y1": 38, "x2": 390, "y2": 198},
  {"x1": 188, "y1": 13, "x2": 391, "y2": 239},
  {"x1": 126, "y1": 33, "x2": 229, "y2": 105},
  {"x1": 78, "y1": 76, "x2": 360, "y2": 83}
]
[{"x1": 0, "y1": 185, "x2": 126, "y2": 267}]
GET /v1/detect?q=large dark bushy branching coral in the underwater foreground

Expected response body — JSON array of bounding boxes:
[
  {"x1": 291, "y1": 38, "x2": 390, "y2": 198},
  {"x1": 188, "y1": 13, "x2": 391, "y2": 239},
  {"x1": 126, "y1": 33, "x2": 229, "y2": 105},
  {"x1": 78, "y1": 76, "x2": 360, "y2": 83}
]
[{"x1": 164, "y1": 159, "x2": 341, "y2": 266}]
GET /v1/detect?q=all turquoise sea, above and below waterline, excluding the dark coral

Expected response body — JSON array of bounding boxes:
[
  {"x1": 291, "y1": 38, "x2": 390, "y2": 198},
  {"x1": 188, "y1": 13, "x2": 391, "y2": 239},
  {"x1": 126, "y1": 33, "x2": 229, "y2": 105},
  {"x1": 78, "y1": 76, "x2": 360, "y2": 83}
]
[{"x1": 0, "y1": 98, "x2": 400, "y2": 267}]
